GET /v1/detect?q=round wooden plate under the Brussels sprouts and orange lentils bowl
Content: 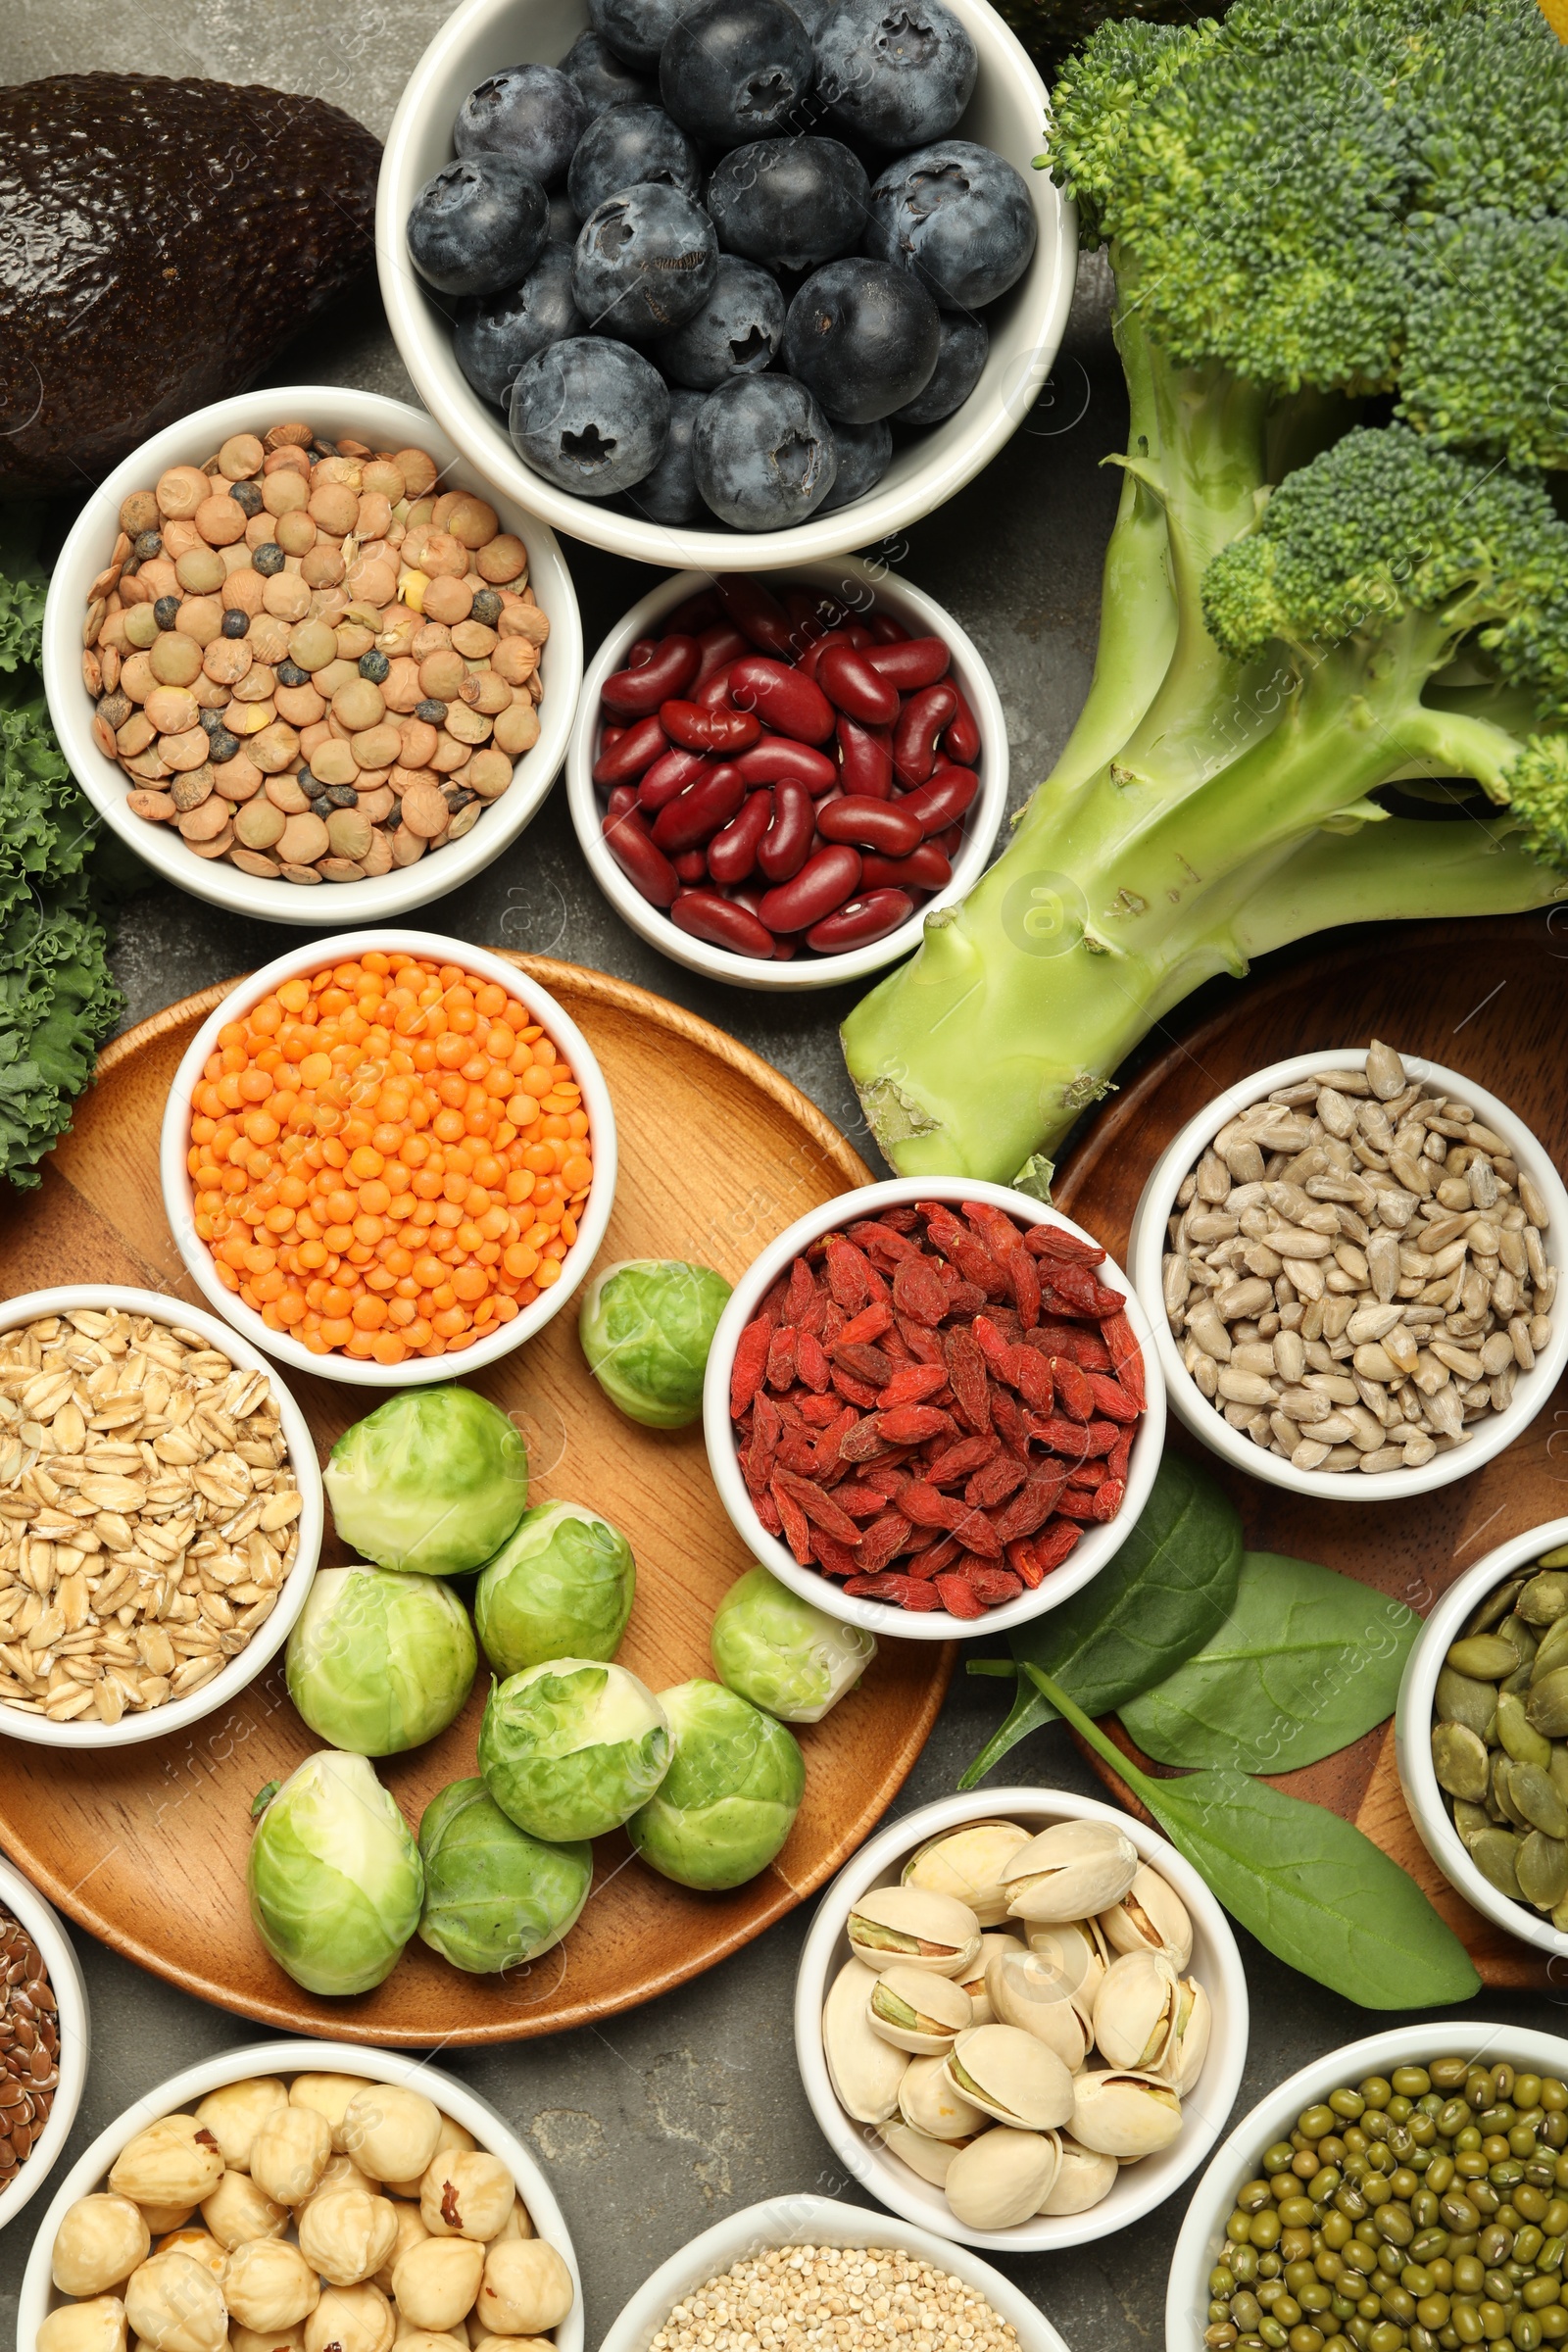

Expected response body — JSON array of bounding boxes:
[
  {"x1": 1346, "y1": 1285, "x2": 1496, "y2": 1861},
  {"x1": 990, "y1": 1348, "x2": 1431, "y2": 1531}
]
[{"x1": 0, "y1": 955, "x2": 955, "y2": 2048}]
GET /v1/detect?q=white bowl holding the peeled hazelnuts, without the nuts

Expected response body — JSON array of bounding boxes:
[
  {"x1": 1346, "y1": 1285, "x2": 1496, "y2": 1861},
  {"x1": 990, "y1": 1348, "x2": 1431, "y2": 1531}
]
[{"x1": 17, "y1": 2041, "x2": 583, "y2": 2352}]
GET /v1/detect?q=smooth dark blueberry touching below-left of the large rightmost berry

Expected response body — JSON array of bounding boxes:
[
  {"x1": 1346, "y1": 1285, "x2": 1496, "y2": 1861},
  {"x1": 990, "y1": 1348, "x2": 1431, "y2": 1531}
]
[{"x1": 783, "y1": 254, "x2": 943, "y2": 425}]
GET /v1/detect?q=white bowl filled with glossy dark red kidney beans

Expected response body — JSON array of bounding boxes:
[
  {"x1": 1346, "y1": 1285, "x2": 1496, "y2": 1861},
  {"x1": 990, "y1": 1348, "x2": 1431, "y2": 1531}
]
[{"x1": 566, "y1": 558, "x2": 1008, "y2": 990}]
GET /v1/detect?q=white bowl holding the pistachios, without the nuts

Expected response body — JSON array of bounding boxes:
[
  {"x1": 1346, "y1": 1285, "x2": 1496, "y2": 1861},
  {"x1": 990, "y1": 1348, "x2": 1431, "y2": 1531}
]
[{"x1": 795, "y1": 1788, "x2": 1249, "y2": 2253}]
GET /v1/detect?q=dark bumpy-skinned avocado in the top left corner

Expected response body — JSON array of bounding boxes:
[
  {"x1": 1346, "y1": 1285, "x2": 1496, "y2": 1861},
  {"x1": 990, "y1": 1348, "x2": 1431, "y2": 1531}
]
[{"x1": 0, "y1": 73, "x2": 381, "y2": 496}]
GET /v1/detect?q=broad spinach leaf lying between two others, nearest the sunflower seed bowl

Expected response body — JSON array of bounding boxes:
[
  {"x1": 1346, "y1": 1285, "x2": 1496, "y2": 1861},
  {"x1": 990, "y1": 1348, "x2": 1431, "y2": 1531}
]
[{"x1": 1119, "y1": 1552, "x2": 1420, "y2": 1771}]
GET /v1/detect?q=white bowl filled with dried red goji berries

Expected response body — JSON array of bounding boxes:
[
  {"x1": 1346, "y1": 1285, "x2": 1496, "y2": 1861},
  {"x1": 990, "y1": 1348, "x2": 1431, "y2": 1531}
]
[{"x1": 703, "y1": 1176, "x2": 1166, "y2": 1642}]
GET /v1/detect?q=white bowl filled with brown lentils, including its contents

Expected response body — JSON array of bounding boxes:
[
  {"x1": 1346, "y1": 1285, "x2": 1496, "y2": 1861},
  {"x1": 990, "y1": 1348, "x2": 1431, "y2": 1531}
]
[{"x1": 45, "y1": 386, "x2": 583, "y2": 924}]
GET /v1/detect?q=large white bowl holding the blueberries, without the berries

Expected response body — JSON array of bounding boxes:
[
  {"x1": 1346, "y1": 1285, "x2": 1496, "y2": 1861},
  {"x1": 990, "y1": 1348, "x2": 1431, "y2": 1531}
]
[{"x1": 376, "y1": 0, "x2": 1077, "y2": 571}]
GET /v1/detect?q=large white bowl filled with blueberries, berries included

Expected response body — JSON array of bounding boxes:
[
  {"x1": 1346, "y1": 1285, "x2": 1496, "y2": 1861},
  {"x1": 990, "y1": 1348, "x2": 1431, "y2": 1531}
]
[{"x1": 376, "y1": 0, "x2": 1077, "y2": 571}]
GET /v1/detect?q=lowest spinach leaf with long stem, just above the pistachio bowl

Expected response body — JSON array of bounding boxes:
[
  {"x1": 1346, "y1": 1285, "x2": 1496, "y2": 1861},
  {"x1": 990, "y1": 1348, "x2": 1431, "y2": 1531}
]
[{"x1": 1022, "y1": 1665, "x2": 1481, "y2": 2009}]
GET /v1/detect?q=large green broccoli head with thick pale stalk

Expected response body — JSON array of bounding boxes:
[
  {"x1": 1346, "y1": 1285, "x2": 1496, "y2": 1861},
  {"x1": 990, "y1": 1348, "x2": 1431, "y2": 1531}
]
[{"x1": 844, "y1": 0, "x2": 1568, "y2": 1181}]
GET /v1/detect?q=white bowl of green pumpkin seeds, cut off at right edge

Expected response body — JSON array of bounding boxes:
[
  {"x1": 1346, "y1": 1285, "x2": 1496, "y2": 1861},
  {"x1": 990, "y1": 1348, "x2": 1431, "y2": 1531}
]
[{"x1": 1394, "y1": 1519, "x2": 1568, "y2": 1957}]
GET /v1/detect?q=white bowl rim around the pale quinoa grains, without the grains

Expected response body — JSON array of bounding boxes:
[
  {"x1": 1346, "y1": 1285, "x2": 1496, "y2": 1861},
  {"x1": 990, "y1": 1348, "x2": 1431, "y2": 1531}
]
[{"x1": 600, "y1": 2189, "x2": 1067, "y2": 2352}]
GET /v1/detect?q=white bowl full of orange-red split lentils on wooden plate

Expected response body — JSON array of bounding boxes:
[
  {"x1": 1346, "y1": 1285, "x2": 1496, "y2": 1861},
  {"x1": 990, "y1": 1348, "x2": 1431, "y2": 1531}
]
[{"x1": 163, "y1": 931, "x2": 615, "y2": 1388}]
